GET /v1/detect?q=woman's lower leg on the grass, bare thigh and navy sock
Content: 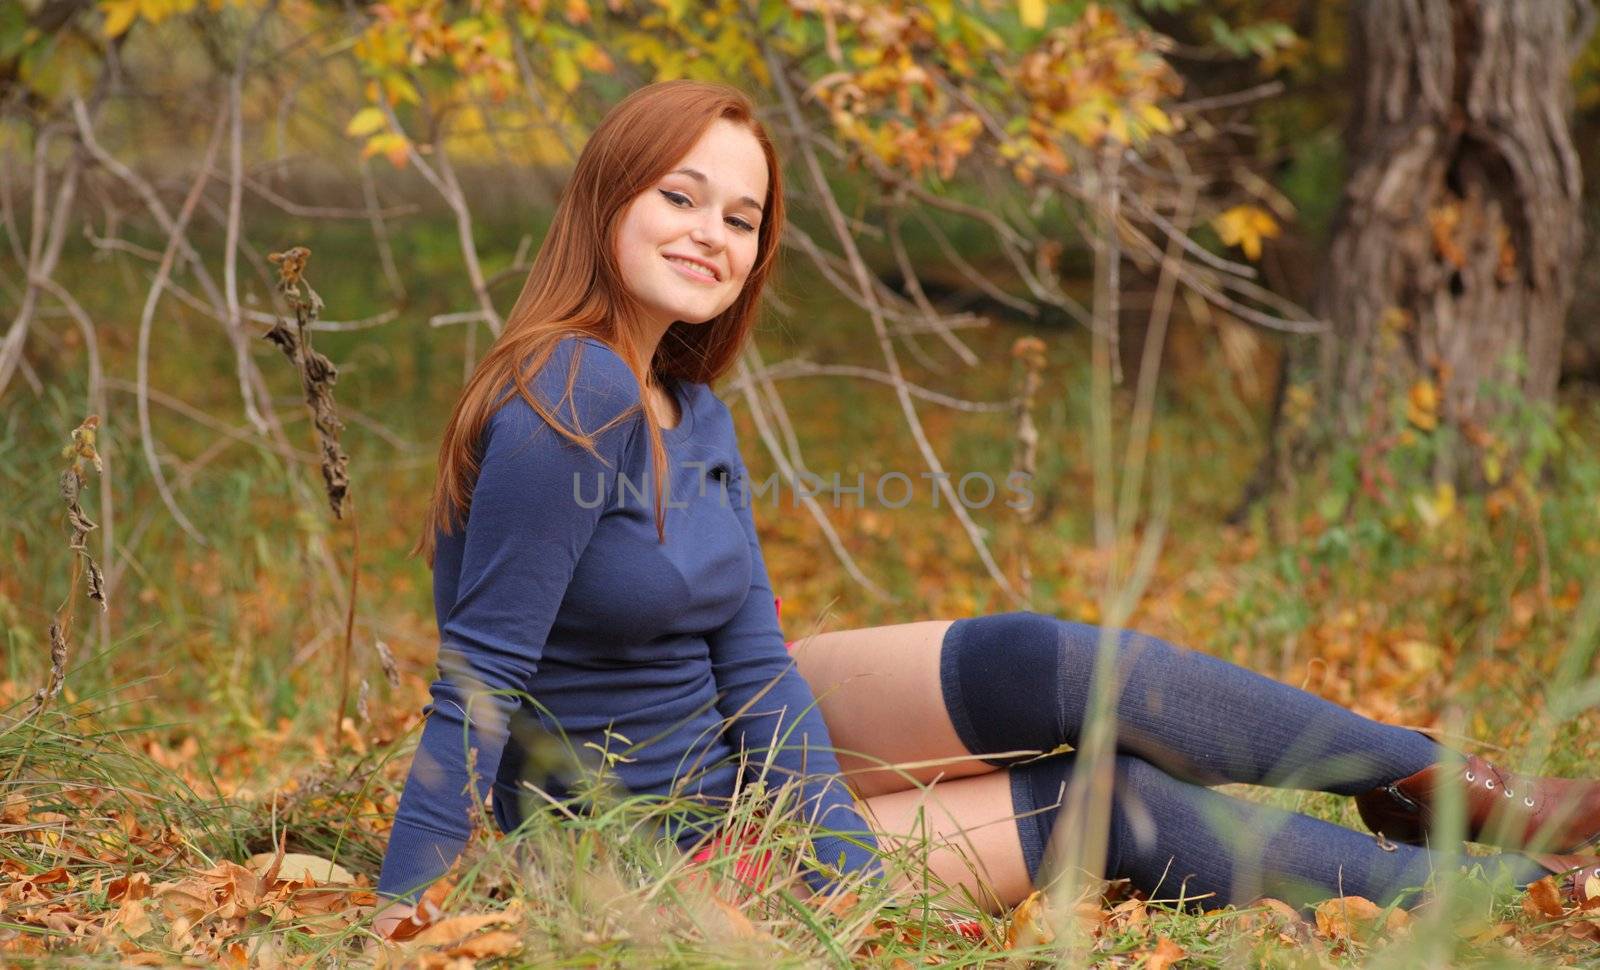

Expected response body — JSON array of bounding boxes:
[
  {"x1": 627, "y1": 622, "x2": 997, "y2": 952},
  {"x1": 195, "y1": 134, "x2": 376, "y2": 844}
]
[{"x1": 866, "y1": 754, "x2": 1546, "y2": 912}]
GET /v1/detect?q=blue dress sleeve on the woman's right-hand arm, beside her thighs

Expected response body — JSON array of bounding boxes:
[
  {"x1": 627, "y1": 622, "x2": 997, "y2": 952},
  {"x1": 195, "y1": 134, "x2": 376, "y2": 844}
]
[{"x1": 707, "y1": 438, "x2": 882, "y2": 888}]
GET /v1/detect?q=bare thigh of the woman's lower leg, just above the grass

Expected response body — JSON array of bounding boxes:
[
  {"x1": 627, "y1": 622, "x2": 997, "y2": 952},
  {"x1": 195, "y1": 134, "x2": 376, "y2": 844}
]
[{"x1": 866, "y1": 770, "x2": 1034, "y2": 912}]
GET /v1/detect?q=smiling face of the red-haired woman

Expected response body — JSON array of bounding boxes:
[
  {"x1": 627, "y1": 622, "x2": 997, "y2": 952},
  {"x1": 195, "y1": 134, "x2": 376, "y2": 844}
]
[{"x1": 616, "y1": 118, "x2": 766, "y2": 331}]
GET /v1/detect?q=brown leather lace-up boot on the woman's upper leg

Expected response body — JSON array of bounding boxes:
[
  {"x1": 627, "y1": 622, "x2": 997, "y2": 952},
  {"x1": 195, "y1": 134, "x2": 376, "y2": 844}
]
[{"x1": 1355, "y1": 754, "x2": 1600, "y2": 853}]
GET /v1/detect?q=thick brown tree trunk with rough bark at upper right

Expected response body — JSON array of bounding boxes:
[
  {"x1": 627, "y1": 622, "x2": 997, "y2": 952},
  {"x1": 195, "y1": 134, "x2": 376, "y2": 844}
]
[{"x1": 1317, "y1": 0, "x2": 1589, "y2": 483}]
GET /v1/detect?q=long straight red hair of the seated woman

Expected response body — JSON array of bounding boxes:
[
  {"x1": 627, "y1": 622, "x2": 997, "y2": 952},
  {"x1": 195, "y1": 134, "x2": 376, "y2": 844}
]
[{"x1": 411, "y1": 80, "x2": 784, "y2": 567}]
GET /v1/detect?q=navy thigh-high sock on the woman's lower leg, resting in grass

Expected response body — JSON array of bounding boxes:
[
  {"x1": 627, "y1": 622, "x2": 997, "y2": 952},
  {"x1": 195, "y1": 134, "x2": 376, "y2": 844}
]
[{"x1": 1010, "y1": 754, "x2": 1546, "y2": 909}]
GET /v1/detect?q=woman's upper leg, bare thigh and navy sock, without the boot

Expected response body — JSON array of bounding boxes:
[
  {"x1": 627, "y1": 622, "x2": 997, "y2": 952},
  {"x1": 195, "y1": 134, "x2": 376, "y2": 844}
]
[{"x1": 794, "y1": 611, "x2": 1443, "y2": 797}]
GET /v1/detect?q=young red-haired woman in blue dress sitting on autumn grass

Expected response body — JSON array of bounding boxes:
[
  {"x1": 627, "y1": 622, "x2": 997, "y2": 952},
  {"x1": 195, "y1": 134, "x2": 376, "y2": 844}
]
[{"x1": 378, "y1": 82, "x2": 1600, "y2": 932}]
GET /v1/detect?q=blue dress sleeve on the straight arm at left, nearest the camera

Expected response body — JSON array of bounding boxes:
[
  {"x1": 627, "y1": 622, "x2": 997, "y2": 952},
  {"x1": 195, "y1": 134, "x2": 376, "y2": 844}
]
[{"x1": 378, "y1": 341, "x2": 638, "y2": 903}]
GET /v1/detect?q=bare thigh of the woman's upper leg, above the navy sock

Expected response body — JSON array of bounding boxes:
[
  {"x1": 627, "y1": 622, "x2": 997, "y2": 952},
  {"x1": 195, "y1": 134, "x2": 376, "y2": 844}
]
[{"x1": 794, "y1": 619, "x2": 995, "y2": 797}]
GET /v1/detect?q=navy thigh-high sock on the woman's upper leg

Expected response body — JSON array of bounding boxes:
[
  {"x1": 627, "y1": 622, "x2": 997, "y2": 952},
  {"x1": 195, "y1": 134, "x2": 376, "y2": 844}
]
[{"x1": 939, "y1": 611, "x2": 1443, "y2": 796}]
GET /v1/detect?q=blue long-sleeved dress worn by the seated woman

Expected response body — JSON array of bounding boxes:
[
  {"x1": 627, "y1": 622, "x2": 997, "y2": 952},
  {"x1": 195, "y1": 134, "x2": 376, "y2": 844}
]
[{"x1": 378, "y1": 336, "x2": 872, "y2": 901}]
